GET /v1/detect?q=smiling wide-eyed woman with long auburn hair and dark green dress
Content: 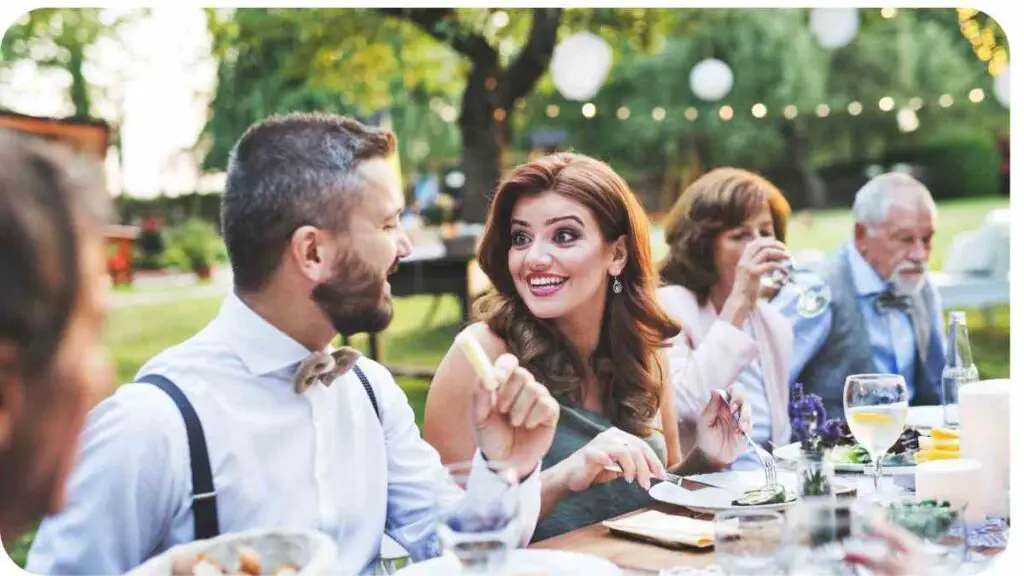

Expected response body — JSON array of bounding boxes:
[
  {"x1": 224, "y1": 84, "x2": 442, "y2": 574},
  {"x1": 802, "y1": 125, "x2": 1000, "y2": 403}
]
[{"x1": 424, "y1": 153, "x2": 742, "y2": 539}]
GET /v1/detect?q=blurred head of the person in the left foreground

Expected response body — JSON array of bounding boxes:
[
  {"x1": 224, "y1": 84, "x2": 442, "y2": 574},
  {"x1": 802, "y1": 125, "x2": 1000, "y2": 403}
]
[{"x1": 0, "y1": 129, "x2": 114, "y2": 542}]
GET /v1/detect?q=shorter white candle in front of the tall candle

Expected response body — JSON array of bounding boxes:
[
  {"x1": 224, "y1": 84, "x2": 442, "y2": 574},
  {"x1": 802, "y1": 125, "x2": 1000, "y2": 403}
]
[{"x1": 913, "y1": 458, "x2": 985, "y2": 524}]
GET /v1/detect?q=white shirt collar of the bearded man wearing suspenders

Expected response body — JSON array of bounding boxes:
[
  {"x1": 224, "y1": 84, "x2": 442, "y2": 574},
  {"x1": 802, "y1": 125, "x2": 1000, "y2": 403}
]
[{"x1": 214, "y1": 290, "x2": 310, "y2": 376}]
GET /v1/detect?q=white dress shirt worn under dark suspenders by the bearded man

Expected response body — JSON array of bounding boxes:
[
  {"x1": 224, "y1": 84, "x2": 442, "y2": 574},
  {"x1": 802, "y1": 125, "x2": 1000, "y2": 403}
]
[{"x1": 27, "y1": 294, "x2": 541, "y2": 574}]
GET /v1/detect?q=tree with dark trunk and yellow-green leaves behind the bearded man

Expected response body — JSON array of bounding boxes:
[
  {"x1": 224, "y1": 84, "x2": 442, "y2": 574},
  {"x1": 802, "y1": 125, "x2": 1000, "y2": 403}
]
[{"x1": 204, "y1": 8, "x2": 671, "y2": 221}]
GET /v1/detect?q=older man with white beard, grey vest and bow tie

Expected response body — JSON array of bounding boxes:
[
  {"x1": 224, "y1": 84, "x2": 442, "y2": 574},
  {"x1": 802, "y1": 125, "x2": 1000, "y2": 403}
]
[{"x1": 772, "y1": 172, "x2": 945, "y2": 417}]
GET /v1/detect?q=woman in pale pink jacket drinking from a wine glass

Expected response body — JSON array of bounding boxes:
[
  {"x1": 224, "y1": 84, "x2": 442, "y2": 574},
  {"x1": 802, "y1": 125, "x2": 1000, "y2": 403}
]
[{"x1": 657, "y1": 168, "x2": 793, "y2": 468}]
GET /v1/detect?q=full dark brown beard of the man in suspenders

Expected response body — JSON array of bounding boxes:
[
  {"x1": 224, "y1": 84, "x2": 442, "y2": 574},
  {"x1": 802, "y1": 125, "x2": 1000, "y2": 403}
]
[{"x1": 312, "y1": 250, "x2": 398, "y2": 335}]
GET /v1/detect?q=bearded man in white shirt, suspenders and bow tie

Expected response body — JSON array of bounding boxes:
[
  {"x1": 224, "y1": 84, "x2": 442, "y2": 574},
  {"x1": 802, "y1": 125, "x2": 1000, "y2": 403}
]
[{"x1": 27, "y1": 114, "x2": 558, "y2": 574}]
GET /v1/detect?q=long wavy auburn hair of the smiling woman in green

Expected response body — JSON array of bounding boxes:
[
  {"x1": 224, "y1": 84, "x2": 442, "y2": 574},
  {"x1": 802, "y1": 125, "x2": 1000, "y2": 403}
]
[{"x1": 477, "y1": 153, "x2": 680, "y2": 436}]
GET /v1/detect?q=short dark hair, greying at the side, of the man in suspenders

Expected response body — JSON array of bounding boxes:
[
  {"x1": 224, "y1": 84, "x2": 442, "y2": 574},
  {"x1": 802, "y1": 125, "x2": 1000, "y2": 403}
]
[{"x1": 220, "y1": 113, "x2": 395, "y2": 292}]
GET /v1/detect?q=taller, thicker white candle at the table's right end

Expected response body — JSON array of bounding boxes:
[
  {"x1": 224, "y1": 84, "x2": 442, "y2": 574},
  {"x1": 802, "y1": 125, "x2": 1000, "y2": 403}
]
[{"x1": 959, "y1": 379, "x2": 1010, "y2": 517}]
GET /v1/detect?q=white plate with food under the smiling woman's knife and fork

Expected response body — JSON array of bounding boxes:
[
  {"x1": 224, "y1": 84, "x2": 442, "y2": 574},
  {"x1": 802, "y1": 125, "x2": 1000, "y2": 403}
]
[{"x1": 649, "y1": 470, "x2": 797, "y2": 513}]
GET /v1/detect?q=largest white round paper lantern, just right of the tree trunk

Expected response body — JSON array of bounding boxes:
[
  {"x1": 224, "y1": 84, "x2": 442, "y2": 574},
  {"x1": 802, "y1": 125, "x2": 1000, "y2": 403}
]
[{"x1": 551, "y1": 32, "x2": 611, "y2": 100}]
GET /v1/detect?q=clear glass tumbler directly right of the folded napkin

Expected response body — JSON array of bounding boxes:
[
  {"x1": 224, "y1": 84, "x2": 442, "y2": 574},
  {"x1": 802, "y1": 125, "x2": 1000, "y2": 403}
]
[{"x1": 715, "y1": 510, "x2": 784, "y2": 576}]
